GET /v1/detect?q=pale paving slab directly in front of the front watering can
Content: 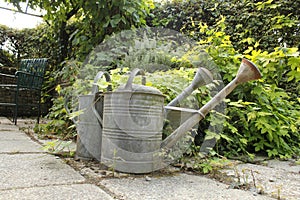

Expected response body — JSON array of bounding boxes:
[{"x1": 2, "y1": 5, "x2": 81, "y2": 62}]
[{"x1": 100, "y1": 173, "x2": 271, "y2": 200}]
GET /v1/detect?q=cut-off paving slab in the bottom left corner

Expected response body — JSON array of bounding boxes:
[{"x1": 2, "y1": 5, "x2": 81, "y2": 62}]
[{"x1": 0, "y1": 184, "x2": 113, "y2": 200}]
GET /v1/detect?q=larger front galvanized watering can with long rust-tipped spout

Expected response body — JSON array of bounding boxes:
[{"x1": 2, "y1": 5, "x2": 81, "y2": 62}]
[{"x1": 101, "y1": 59, "x2": 261, "y2": 174}]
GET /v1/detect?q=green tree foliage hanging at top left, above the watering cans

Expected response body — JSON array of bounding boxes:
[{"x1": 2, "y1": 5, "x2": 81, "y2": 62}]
[{"x1": 7, "y1": 0, "x2": 154, "y2": 61}]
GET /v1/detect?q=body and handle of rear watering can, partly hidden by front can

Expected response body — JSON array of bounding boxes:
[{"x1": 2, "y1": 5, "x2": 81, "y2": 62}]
[{"x1": 65, "y1": 72, "x2": 111, "y2": 161}]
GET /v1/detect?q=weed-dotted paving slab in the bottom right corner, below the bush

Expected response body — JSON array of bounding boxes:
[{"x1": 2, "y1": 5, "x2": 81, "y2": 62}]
[{"x1": 223, "y1": 160, "x2": 300, "y2": 200}]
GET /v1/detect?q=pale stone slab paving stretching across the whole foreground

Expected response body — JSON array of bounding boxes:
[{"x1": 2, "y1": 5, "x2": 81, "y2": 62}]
[{"x1": 0, "y1": 117, "x2": 300, "y2": 200}]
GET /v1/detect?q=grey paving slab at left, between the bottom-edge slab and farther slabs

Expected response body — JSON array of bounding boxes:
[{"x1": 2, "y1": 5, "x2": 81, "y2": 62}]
[{"x1": 0, "y1": 154, "x2": 85, "y2": 190}]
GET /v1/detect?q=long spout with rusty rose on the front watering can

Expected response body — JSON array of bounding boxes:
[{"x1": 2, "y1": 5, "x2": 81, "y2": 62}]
[{"x1": 161, "y1": 59, "x2": 261, "y2": 148}]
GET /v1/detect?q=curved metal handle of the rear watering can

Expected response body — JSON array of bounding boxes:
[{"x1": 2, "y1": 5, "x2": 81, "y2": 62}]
[{"x1": 92, "y1": 71, "x2": 112, "y2": 126}]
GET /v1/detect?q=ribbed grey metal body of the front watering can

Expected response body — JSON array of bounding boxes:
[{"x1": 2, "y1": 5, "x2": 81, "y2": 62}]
[{"x1": 101, "y1": 71, "x2": 164, "y2": 173}]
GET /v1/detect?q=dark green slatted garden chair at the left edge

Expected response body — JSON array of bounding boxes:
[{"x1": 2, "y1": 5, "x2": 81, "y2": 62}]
[{"x1": 0, "y1": 58, "x2": 48, "y2": 124}]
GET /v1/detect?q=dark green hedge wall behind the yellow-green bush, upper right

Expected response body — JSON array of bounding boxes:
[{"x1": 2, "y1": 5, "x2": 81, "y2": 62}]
[{"x1": 148, "y1": 0, "x2": 300, "y2": 51}]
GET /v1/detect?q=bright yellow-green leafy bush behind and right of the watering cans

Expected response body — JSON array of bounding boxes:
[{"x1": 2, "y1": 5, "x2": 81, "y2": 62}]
[{"x1": 41, "y1": 18, "x2": 300, "y2": 159}]
